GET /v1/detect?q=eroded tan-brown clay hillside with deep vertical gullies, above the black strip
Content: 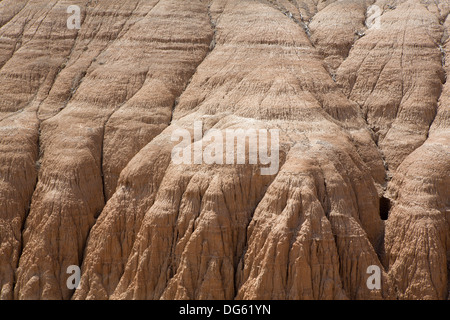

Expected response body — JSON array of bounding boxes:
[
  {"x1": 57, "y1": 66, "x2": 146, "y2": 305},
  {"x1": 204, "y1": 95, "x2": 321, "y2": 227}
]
[{"x1": 0, "y1": 0, "x2": 450, "y2": 299}]
